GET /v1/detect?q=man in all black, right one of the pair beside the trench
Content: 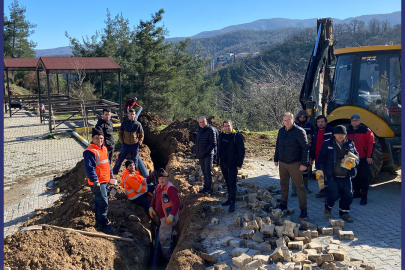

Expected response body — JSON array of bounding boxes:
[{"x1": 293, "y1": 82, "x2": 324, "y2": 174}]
[{"x1": 218, "y1": 120, "x2": 245, "y2": 212}]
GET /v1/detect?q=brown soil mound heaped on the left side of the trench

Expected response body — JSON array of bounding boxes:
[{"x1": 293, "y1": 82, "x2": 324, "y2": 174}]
[{"x1": 4, "y1": 146, "x2": 153, "y2": 270}]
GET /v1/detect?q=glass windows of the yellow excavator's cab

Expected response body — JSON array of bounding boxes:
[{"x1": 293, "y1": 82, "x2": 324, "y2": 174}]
[{"x1": 328, "y1": 51, "x2": 401, "y2": 125}]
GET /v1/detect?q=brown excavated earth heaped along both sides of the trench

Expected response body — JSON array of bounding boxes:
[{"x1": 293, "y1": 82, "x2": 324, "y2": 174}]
[{"x1": 4, "y1": 112, "x2": 274, "y2": 270}]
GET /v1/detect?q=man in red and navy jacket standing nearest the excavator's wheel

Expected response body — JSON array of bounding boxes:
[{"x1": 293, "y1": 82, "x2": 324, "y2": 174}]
[{"x1": 347, "y1": 114, "x2": 374, "y2": 205}]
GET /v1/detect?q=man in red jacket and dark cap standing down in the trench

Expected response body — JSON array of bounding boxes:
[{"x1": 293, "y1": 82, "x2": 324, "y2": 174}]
[{"x1": 149, "y1": 168, "x2": 180, "y2": 260}]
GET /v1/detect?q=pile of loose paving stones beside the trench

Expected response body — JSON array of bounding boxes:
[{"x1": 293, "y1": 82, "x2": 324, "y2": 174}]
[{"x1": 178, "y1": 165, "x2": 375, "y2": 270}]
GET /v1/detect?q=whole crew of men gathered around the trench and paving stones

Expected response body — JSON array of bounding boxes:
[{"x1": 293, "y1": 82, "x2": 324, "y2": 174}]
[{"x1": 83, "y1": 101, "x2": 374, "y2": 259}]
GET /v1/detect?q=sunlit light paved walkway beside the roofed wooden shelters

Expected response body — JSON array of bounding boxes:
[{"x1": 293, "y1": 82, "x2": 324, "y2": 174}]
[{"x1": 4, "y1": 111, "x2": 89, "y2": 236}]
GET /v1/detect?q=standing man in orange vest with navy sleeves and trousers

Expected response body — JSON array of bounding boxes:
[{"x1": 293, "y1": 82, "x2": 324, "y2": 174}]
[{"x1": 83, "y1": 128, "x2": 116, "y2": 233}]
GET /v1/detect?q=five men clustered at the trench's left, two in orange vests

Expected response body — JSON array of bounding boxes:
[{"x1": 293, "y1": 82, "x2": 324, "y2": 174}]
[{"x1": 83, "y1": 103, "x2": 180, "y2": 259}]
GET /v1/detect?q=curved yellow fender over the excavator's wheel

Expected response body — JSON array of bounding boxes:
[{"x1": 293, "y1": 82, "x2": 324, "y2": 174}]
[{"x1": 326, "y1": 106, "x2": 394, "y2": 138}]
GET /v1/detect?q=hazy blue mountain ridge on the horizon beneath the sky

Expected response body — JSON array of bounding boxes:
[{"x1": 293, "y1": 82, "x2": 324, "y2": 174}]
[{"x1": 35, "y1": 11, "x2": 401, "y2": 57}]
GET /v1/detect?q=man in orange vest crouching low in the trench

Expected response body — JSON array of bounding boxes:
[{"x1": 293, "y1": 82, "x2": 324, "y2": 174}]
[{"x1": 120, "y1": 160, "x2": 155, "y2": 212}]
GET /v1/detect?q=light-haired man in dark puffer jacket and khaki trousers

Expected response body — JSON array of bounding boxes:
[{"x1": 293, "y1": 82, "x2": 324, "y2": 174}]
[{"x1": 274, "y1": 112, "x2": 308, "y2": 220}]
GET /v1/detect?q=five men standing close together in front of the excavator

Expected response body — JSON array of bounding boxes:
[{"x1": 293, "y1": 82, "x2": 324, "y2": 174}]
[{"x1": 274, "y1": 110, "x2": 375, "y2": 222}]
